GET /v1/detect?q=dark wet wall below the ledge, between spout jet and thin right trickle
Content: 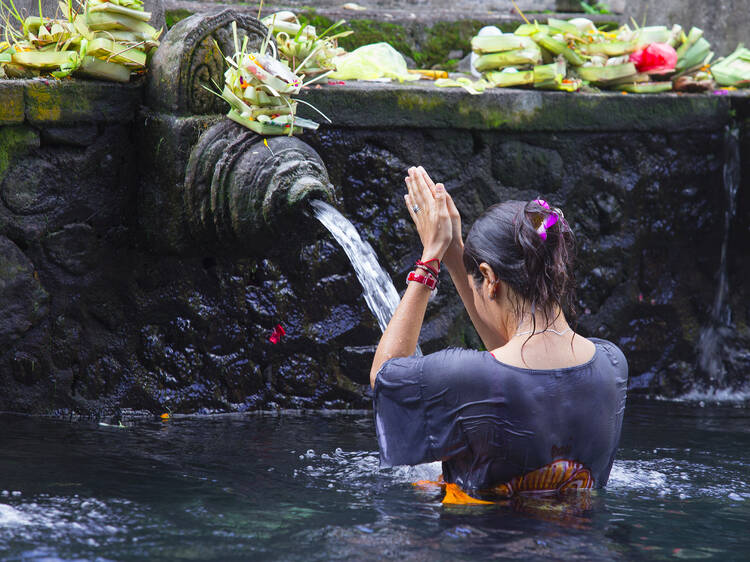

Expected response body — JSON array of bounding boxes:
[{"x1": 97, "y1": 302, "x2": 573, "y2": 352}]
[{"x1": 304, "y1": 126, "x2": 748, "y2": 395}]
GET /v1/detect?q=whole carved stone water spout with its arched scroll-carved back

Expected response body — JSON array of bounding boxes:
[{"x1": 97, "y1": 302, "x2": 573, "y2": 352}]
[{"x1": 139, "y1": 10, "x2": 333, "y2": 254}]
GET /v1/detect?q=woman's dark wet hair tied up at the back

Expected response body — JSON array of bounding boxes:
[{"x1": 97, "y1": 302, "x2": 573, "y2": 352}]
[{"x1": 463, "y1": 200, "x2": 575, "y2": 329}]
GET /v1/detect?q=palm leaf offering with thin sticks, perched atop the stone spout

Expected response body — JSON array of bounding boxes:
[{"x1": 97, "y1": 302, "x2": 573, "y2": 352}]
[{"x1": 206, "y1": 22, "x2": 328, "y2": 136}]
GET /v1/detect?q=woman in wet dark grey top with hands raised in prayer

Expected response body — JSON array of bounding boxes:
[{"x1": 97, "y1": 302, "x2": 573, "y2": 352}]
[{"x1": 370, "y1": 167, "x2": 627, "y2": 495}]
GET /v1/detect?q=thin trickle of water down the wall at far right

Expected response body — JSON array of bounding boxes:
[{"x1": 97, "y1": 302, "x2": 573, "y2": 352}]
[{"x1": 698, "y1": 127, "x2": 740, "y2": 389}]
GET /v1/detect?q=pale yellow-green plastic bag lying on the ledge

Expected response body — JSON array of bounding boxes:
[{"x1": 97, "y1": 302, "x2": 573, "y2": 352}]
[{"x1": 328, "y1": 43, "x2": 419, "y2": 82}]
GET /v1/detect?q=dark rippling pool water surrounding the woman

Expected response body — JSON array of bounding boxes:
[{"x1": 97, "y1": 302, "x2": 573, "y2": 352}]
[{"x1": 0, "y1": 400, "x2": 750, "y2": 562}]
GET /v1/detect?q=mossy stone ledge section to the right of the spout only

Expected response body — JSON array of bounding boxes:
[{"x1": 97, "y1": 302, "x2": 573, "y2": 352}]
[{"x1": 299, "y1": 81, "x2": 744, "y2": 132}]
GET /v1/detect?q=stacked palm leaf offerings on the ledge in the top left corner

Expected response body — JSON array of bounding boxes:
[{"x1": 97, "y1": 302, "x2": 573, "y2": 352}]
[{"x1": 0, "y1": 0, "x2": 161, "y2": 82}]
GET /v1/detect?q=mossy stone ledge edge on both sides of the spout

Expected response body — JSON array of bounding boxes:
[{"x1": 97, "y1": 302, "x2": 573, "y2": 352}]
[{"x1": 0, "y1": 75, "x2": 750, "y2": 132}]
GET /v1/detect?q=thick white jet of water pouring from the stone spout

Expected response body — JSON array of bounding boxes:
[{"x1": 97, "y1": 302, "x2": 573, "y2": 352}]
[{"x1": 310, "y1": 200, "x2": 422, "y2": 355}]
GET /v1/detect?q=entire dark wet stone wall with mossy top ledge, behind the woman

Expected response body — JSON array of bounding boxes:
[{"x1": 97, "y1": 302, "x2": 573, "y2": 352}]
[{"x1": 0, "y1": 70, "x2": 750, "y2": 415}]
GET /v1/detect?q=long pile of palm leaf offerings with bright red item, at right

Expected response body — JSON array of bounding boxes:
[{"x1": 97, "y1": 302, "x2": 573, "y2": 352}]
[{"x1": 471, "y1": 18, "x2": 750, "y2": 93}]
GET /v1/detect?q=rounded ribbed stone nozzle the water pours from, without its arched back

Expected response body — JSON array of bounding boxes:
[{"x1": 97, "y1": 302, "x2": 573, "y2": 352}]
[{"x1": 184, "y1": 119, "x2": 333, "y2": 245}]
